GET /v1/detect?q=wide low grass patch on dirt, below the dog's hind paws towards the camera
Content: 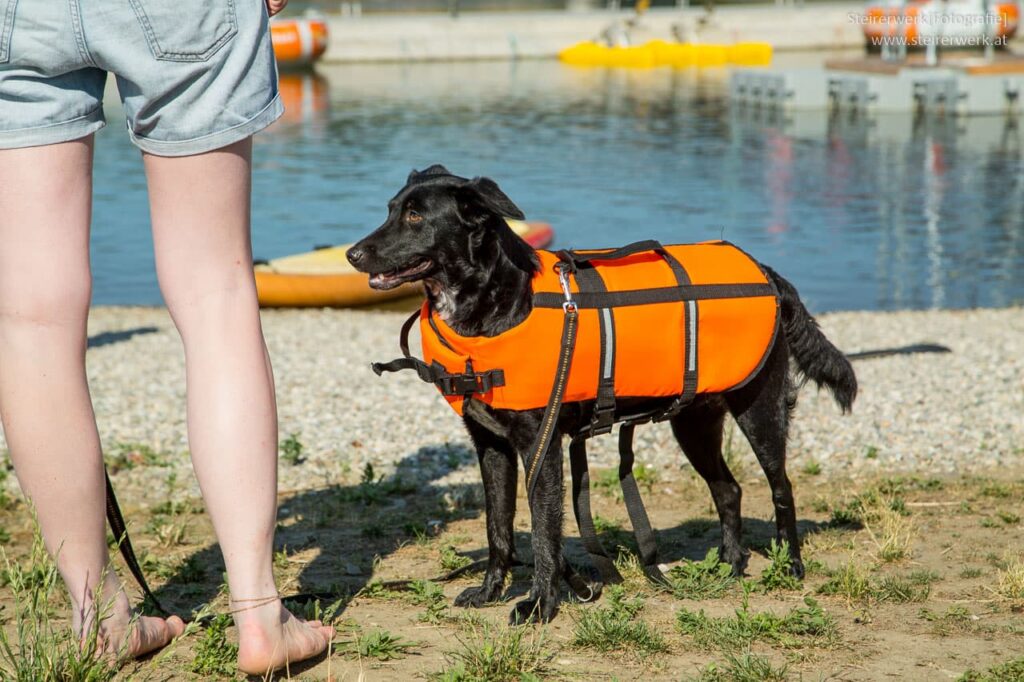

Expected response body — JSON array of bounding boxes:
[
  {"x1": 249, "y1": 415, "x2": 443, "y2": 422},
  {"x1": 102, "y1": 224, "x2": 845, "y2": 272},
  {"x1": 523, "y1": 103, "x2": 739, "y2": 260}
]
[{"x1": 676, "y1": 587, "x2": 839, "y2": 651}]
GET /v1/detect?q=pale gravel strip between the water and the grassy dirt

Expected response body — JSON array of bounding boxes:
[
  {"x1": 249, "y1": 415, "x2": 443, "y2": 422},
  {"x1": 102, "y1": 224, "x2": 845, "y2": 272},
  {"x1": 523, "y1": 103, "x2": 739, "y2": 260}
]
[{"x1": 2, "y1": 307, "x2": 1024, "y2": 495}]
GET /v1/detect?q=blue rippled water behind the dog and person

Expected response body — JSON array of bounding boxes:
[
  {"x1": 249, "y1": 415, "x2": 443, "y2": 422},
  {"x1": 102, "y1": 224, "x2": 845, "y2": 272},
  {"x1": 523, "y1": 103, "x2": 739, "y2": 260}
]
[{"x1": 93, "y1": 58, "x2": 1024, "y2": 311}]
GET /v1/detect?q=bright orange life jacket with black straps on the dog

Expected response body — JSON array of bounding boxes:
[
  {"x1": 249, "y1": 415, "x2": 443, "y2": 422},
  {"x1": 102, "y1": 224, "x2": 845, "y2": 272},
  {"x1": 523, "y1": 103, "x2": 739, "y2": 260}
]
[{"x1": 405, "y1": 242, "x2": 778, "y2": 415}]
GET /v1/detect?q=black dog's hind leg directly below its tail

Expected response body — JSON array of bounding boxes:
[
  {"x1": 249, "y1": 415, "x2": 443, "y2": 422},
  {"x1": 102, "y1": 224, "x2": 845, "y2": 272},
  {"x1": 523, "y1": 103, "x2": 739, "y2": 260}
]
[{"x1": 725, "y1": 335, "x2": 804, "y2": 578}]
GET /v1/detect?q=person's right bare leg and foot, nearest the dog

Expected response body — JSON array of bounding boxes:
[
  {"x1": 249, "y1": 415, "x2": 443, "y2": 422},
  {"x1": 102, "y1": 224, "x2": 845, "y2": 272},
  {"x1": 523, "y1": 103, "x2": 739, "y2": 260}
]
[{"x1": 143, "y1": 140, "x2": 334, "y2": 674}]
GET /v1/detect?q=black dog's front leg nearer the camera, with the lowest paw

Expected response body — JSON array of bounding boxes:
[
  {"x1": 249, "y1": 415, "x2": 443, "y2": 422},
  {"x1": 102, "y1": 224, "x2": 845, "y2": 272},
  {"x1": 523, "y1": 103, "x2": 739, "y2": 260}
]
[{"x1": 509, "y1": 433, "x2": 564, "y2": 625}]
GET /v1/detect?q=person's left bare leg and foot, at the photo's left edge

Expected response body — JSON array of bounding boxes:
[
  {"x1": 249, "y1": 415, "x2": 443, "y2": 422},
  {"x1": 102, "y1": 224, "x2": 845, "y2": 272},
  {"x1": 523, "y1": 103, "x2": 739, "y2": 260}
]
[{"x1": 0, "y1": 136, "x2": 184, "y2": 655}]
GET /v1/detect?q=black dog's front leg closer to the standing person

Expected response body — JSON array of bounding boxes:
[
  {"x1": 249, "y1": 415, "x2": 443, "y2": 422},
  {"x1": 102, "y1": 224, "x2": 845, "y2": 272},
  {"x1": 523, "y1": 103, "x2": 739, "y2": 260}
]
[{"x1": 455, "y1": 419, "x2": 517, "y2": 607}]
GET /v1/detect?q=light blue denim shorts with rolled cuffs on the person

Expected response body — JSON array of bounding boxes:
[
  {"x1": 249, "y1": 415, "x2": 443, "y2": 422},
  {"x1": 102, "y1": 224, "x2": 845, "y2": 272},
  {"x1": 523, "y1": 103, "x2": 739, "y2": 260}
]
[{"x1": 0, "y1": 0, "x2": 284, "y2": 157}]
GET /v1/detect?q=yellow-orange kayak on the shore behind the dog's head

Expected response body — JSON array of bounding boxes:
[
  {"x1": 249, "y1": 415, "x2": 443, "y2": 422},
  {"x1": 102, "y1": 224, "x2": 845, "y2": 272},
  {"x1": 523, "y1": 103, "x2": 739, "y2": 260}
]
[{"x1": 253, "y1": 220, "x2": 554, "y2": 308}]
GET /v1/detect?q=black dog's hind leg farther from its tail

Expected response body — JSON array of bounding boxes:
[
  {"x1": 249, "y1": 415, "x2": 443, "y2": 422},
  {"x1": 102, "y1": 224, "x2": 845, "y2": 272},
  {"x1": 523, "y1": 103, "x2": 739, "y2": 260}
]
[{"x1": 672, "y1": 398, "x2": 750, "y2": 576}]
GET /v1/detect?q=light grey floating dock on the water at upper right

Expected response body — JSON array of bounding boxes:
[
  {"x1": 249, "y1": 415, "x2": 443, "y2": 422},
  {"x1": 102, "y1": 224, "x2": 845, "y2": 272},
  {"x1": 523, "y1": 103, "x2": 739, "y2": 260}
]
[{"x1": 729, "y1": 54, "x2": 1024, "y2": 116}]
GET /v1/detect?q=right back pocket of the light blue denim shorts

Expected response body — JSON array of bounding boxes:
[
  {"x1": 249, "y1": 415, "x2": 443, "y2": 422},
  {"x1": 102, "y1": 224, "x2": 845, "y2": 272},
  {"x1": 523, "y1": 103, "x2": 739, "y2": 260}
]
[{"x1": 129, "y1": 0, "x2": 236, "y2": 61}]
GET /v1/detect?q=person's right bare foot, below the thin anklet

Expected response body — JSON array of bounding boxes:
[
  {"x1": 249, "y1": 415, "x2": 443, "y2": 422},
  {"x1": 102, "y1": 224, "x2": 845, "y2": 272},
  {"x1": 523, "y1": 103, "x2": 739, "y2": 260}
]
[{"x1": 236, "y1": 601, "x2": 334, "y2": 675}]
